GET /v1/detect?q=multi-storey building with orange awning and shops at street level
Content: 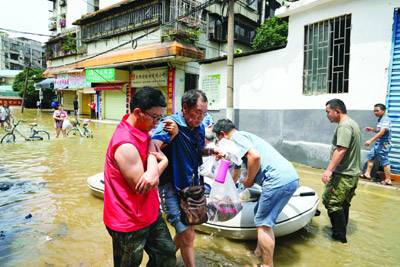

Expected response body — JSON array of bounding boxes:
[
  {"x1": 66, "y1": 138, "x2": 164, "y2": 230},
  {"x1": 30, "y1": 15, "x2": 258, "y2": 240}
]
[{"x1": 45, "y1": 0, "x2": 276, "y2": 119}]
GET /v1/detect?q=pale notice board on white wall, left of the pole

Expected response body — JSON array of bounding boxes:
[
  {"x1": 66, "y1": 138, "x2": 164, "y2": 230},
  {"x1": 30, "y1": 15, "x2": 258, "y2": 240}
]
[{"x1": 201, "y1": 74, "x2": 221, "y2": 110}]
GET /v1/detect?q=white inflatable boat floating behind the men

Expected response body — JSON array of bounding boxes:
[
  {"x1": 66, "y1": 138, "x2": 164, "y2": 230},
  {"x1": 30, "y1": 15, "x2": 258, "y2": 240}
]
[{"x1": 87, "y1": 173, "x2": 319, "y2": 240}]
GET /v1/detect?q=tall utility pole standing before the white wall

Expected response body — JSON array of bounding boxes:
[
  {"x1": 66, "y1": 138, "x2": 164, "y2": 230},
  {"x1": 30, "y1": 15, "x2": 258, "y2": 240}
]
[{"x1": 226, "y1": 0, "x2": 235, "y2": 122}]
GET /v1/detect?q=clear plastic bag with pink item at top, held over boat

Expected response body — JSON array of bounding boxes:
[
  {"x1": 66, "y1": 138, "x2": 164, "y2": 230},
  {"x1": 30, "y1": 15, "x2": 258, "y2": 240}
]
[{"x1": 207, "y1": 160, "x2": 242, "y2": 222}]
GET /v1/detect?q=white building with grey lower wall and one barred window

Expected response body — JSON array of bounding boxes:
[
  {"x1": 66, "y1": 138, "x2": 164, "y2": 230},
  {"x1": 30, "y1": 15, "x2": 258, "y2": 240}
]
[{"x1": 200, "y1": 0, "x2": 400, "y2": 171}]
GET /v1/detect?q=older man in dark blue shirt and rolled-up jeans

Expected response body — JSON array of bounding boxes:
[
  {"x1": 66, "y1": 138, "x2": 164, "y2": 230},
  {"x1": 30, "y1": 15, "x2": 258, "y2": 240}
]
[{"x1": 152, "y1": 90, "x2": 220, "y2": 267}]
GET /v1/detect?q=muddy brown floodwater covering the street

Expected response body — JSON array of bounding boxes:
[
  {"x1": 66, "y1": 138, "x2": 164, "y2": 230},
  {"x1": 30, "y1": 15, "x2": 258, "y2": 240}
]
[{"x1": 0, "y1": 110, "x2": 400, "y2": 267}]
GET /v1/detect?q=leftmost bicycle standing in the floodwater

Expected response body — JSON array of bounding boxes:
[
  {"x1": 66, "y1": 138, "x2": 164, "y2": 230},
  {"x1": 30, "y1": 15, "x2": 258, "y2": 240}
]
[{"x1": 0, "y1": 120, "x2": 50, "y2": 144}]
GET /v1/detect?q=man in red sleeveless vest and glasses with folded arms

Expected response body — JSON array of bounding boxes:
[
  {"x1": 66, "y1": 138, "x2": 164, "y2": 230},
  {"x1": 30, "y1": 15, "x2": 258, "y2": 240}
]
[{"x1": 103, "y1": 87, "x2": 176, "y2": 267}]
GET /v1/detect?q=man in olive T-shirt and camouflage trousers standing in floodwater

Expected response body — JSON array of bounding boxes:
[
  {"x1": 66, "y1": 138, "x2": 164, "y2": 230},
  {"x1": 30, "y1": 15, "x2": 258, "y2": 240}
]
[{"x1": 322, "y1": 99, "x2": 361, "y2": 243}]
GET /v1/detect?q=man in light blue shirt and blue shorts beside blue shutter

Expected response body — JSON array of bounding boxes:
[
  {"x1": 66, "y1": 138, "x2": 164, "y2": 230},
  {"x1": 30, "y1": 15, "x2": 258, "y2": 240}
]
[{"x1": 363, "y1": 103, "x2": 392, "y2": 185}]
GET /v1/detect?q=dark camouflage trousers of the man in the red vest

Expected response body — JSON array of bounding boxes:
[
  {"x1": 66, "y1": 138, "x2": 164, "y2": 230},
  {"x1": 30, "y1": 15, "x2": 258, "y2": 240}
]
[{"x1": 107, "y1": 214, "x2": 176, "y2": 267}]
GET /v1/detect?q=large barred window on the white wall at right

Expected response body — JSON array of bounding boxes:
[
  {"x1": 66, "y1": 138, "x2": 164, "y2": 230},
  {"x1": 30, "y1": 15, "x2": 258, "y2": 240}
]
[{"x1": 303, "y1": 15, "x2": 351, "y2": 95}]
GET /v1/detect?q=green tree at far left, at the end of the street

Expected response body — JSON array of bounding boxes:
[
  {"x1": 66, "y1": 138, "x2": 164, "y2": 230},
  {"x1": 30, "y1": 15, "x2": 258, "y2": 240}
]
[{"x1": 13, "y1": 68, "x2": 55, "y2": 108}]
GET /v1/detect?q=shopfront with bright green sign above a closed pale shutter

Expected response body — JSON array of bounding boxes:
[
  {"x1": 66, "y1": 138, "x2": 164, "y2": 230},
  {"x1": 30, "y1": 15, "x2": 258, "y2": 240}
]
[{"x1": 86, "y1": 68, "x2": 129, "y2": 120}]
